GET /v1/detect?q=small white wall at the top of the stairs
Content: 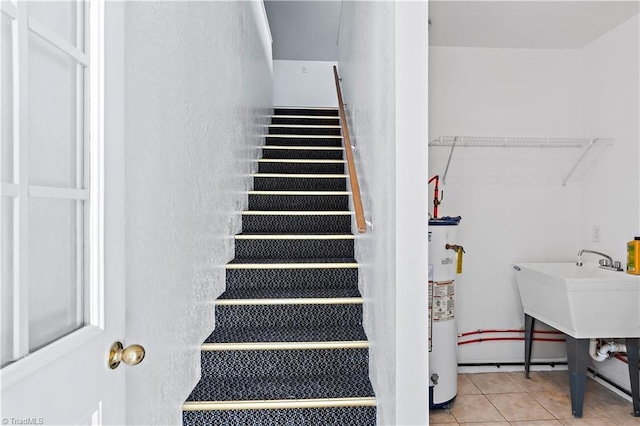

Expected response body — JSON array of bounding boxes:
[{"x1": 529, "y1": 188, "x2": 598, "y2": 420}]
[{"x1": 273, "y1": 61, "x2": 338, "y2": 107}]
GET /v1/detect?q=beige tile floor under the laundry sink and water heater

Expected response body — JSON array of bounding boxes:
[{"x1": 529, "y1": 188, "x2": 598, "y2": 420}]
[{"x1": 429, "y1": 371, "x2": 640, "y2": 426}]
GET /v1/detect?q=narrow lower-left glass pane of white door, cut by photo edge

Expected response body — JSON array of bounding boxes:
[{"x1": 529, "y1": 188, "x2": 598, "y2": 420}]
[{"x1": 0, "y1": 197, "x2": 14, "y2": 365}]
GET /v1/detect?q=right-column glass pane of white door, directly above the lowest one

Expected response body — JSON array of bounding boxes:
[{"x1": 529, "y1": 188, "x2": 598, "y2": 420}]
[{"x1": 29, "y1": 34, "x2": 77, "y2": 188}]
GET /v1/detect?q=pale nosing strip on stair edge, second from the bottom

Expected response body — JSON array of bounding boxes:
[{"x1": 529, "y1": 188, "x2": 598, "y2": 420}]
[{"x1": 200, "y1": 340, "x2": 369, "y2": 351}]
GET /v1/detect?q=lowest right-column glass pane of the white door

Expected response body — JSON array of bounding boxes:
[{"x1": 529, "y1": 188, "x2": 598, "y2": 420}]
[{"x1": 29, "y1": 198, "x2": 83, "y2": 352}]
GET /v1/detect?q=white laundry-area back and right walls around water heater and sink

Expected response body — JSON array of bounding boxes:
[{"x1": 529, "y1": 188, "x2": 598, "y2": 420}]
[{"x1": 429, "y1": 16, "x2": 640, "y2": 372}]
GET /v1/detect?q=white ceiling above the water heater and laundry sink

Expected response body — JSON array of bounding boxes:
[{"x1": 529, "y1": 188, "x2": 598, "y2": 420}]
[{"x1": 429, "y1": 0, "x2": 640, "y2": 49}]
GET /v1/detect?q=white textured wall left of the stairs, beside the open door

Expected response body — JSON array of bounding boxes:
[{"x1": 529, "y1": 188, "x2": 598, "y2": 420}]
[{"x1": 126, "y1": 2, "x2": 272, "y2": 424}]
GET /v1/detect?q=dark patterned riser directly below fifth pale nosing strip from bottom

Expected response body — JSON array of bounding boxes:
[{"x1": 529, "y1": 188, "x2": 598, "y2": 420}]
[{"x1": 236, "y1": 239, "x2": 354, "y2": 259}]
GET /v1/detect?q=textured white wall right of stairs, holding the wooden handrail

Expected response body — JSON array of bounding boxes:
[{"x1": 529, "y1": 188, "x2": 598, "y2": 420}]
[{"x1": 338, "y1": 2, "x2": 396, "y2": 425}]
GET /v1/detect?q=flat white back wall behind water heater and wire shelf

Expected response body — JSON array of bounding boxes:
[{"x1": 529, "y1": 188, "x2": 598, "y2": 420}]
[{"x1": 429, "y1": 47, "x2": 583, "y2": 363}]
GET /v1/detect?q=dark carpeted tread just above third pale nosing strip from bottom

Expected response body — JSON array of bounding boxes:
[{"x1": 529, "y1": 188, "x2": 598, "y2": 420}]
[{"x1": 218, "y1": 283, "x2": 362, "y2": 300}]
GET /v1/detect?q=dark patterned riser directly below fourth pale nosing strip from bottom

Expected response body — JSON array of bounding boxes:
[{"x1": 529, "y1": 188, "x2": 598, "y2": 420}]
[{"x1": 226, "y1": 268, "x2": 358, "y2": 290}]
